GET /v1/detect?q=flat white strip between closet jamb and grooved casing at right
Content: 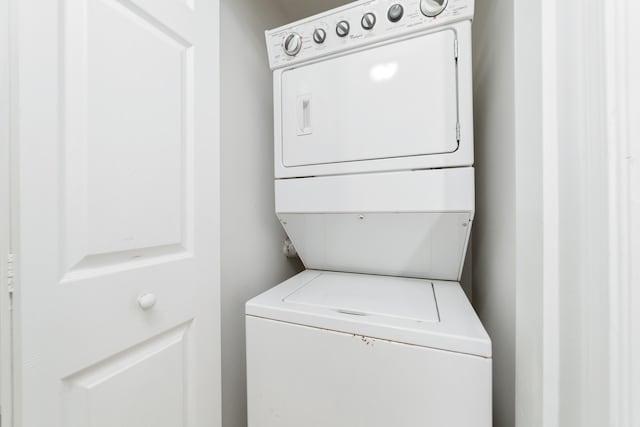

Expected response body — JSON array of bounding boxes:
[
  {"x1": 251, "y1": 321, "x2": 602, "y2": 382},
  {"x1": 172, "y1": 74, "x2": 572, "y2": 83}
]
[{"x1": 557, "y1": 0, "x2": 610, "y2": 427}]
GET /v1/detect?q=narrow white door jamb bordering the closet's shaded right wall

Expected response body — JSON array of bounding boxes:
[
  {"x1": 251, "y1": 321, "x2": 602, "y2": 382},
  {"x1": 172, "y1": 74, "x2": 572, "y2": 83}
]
[{"x1": 513, "y1": 0, "x2": 544, "y2": 427}]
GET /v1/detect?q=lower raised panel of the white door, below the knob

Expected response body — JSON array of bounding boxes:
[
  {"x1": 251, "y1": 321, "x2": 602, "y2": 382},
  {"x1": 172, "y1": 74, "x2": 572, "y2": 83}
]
[{"x1": 62, "y1": 322, "x2": 194, "y2": 427}]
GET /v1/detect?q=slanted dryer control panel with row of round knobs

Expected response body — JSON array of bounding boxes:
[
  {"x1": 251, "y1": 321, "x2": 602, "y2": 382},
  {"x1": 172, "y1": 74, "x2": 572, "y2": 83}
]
[{"x1": 266, "y1": 0, "x2": 474, "y2": 69}]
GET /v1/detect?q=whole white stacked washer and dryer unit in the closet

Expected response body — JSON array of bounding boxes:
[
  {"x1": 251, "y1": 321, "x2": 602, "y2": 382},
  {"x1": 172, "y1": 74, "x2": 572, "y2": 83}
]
[{"x1": 246, "y1": 0, "x2": 491, "y2": 427}]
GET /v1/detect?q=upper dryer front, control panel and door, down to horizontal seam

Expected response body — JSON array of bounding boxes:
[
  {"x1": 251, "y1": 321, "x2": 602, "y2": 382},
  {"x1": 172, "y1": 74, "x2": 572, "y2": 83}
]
[{"x1": 267, "y1": 0, "x2": 473, "y2": 178}]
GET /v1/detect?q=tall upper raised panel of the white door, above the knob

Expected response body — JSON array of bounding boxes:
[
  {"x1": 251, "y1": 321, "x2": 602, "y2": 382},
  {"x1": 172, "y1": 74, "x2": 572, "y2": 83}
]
[{"x1": 60, "y1": 0, "x2": 193, "y2": 281}]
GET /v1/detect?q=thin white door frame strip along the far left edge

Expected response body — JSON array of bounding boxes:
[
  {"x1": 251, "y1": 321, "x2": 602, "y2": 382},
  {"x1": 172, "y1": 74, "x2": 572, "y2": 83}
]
[{"x1": 0, "y1": 0, "x2": 15, "y2": 427}]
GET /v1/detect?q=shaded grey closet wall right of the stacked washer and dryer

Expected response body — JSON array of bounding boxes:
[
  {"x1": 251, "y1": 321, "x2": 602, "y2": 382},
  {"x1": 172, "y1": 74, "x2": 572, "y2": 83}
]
[{"x1": 473, "y1": 0, "x2": 516, "y2": 427}]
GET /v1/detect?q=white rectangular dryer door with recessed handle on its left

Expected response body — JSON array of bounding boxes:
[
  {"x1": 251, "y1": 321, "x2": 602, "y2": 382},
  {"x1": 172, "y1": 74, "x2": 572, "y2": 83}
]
[{"x1": 281, "y1": 29, "x2": 458, "y2": 167}]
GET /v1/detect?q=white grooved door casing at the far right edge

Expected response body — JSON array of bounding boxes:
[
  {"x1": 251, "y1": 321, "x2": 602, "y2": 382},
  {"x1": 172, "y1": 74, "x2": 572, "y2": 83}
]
[{"x1": 605, "y1": 0, "x2": 640, "y2": 427}]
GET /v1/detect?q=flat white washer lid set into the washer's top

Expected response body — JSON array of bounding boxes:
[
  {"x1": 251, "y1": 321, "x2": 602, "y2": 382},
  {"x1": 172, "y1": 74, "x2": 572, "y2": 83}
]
[{"x1": 284, "y1": 272, "x2": 439, "y2": 322}]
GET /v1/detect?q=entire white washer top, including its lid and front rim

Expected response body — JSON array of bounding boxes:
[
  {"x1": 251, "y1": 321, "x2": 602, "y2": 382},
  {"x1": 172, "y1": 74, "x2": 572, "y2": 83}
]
[{"x1": 246, "y1": 270, "x2": 491, "y2": 358}]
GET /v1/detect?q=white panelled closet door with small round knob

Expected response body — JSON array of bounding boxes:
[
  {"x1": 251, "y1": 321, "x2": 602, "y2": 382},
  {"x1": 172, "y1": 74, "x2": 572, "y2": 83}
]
[{"x1": 13, "y1": 0, "x2": 220, "y2": 427}]
